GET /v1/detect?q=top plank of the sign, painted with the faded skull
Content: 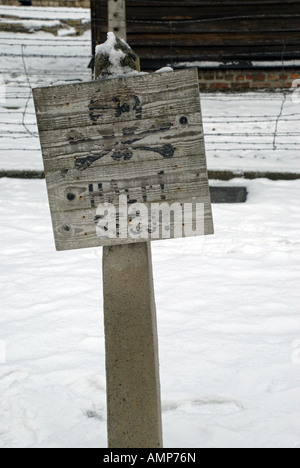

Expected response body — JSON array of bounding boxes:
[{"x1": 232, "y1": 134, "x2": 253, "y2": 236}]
[{"x1": 34, "y1": 71, "x2": 199, "y2": 133}]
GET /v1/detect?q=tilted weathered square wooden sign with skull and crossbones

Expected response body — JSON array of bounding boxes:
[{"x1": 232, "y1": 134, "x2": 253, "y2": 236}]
[{"x1": 34, "y1": 69, "x2": 213, "y2": 250}]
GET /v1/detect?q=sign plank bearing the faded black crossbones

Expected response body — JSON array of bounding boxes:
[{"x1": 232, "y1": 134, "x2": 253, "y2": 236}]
[{"x1": 37, "y1": 109, "x2": 203, "y2": 165}]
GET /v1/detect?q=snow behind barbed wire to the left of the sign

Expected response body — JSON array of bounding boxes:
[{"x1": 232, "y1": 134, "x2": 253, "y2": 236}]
[{"x1": 0, "y1": 6, "x2": 91, "y2": 170}]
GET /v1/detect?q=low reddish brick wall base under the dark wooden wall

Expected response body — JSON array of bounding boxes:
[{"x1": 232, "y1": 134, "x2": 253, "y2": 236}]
[{"x1": 199, "y1": 68, "x2": 300, "y2": 92}]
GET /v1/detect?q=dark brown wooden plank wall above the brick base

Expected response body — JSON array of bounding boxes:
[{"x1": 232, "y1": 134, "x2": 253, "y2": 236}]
[{"x1": 91, "y1": 0, "x2": 300, "y2": 69}]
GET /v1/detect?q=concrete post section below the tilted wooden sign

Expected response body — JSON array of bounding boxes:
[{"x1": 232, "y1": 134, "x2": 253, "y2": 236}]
[{"x1": 103, "y1": 243, "x2": 162, "y2": 448}]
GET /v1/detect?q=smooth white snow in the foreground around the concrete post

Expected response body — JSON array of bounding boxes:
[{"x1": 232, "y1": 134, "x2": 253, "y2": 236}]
[{"x1": 0, "y1": 179, "x2": 300, "y2": 448}]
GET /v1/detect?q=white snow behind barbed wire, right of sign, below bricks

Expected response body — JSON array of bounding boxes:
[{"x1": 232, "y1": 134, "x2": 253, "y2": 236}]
[{"x1": 200, "y1": 94, "x2": 300, "y2": 173}]
